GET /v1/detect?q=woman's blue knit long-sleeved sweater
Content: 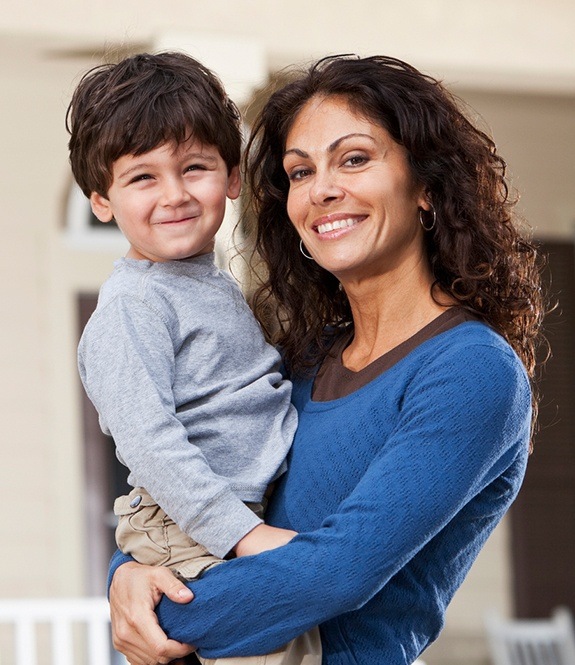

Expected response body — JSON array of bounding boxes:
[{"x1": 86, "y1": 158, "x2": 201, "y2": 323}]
[{"x1": 111, "y1": 322, "x2": 531, "y2": 665}]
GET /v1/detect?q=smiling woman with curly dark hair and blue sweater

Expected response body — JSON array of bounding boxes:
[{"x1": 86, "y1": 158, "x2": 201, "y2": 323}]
[{"x1": 111, "y1": 56, "x2": 542, "y2": 665}]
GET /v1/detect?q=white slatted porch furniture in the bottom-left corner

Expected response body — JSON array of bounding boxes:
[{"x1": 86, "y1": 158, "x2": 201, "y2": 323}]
[{"x1": 0, "y1": 598, "x2": 126, "y2": 665}]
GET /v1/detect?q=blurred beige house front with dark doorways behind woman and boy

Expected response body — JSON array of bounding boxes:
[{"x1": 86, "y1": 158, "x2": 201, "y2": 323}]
[{"x1": 0, "y1": 0, "x2": 575, "y2": 665}]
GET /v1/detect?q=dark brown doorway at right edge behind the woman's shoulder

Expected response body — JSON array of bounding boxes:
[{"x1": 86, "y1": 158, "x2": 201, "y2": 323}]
[{"x1": 511, "y1": 241, "x2": 575, "y2": 617}]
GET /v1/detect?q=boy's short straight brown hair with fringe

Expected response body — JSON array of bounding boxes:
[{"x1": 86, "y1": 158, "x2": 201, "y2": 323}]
[{"x1": 66, "y1": 52, "x2": 242, "y2": 197}]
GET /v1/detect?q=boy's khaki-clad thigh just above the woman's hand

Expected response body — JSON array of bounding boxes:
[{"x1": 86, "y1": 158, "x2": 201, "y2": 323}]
[{"x1": 114, "y1": 487, "x2": 222, "y2": 579}]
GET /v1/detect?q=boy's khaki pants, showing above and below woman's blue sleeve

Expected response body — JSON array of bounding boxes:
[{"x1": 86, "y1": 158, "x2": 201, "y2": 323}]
[{"x1": 114, "y1": 487, "x2": 321, "y2": 665}]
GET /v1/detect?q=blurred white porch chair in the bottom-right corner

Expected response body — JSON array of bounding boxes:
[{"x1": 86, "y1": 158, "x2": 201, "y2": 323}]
[{"x1": 485, "y1": 608, "x2": 575, "y2": 665}]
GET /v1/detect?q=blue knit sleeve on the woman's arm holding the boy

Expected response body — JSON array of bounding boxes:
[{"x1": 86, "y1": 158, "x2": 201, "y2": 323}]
[{"x1": 111, "y1": 346, "x2": 530, "y2": 658}]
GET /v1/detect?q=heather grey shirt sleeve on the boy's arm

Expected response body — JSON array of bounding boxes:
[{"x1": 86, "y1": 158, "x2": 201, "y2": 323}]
[{"x1": 78, "y1": 296, "x2": 261, "y2": 557}]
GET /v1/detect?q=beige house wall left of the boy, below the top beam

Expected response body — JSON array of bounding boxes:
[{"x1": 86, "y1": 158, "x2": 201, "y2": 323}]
[{"x1": 0, "y1": 39, "x2": 121, "y2": 596}]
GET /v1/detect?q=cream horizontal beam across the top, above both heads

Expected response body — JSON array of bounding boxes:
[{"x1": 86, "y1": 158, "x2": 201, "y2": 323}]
[{"x1": 0, "y1": 0, "x2": 575, "y2": 89}]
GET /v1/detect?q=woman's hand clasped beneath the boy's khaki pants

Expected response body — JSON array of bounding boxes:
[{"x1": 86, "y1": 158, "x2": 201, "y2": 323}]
[{"x1": 110, "y1": 563, "x2": 195, "y2": 665}]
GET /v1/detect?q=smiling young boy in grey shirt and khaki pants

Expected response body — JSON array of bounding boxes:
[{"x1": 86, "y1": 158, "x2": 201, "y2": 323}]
[{"x1": 67, "y1": 53, "x2": 321, "y2": 664}]
